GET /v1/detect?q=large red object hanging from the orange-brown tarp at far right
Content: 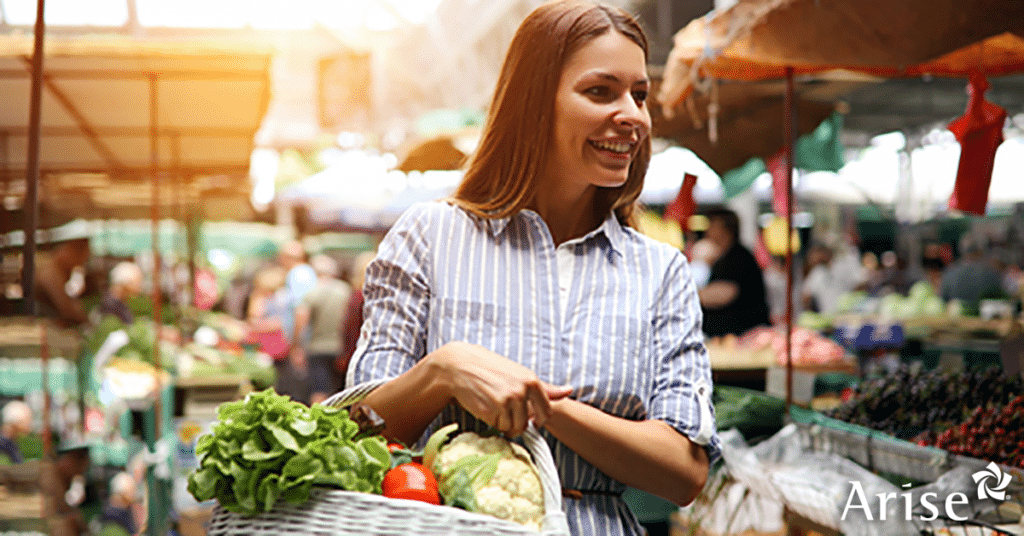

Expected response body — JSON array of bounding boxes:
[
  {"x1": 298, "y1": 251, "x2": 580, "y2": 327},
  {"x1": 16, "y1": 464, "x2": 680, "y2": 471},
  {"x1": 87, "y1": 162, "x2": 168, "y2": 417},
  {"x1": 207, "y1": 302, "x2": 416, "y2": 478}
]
[{"x1": 948, "y1": 73, "x2": 1007, "y2": 215}]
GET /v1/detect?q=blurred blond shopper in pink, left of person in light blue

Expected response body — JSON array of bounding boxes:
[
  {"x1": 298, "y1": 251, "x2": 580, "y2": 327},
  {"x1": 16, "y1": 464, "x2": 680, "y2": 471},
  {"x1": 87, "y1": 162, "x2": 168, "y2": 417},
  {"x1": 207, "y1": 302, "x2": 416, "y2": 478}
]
[{"x1": 246, "y1": 266, "x2": 309, "y2": 401}]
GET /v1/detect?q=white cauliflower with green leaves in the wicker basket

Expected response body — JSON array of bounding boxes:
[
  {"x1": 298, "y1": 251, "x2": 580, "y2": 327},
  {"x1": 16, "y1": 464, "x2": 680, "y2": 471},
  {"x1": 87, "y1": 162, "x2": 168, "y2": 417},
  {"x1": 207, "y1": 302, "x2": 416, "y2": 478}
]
[{"x1": 424, "y1": 424, "x2": 544, "y2": 531}]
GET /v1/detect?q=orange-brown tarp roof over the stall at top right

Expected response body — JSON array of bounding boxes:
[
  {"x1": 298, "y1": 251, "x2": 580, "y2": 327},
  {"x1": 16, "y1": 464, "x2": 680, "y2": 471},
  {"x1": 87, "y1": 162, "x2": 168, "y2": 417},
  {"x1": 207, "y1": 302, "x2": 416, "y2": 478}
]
[{"x1": 659, "y1": 0, "x2": 1024, "y2": 113}]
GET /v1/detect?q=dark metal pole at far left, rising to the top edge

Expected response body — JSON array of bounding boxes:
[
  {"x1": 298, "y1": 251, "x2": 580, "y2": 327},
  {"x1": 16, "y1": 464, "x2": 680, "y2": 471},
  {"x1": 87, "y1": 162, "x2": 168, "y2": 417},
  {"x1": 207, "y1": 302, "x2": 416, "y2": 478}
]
[{"x1": 22, "y1": 0, "x2": 46, "y2": 317}]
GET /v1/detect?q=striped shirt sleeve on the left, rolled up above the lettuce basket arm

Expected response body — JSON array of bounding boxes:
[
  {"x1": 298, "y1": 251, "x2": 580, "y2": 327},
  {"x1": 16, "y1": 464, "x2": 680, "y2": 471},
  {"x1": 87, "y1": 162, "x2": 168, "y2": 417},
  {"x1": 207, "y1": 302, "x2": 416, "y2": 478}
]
[{"x1": 345, "y1": 205, "x2": 430, "y2": 386}]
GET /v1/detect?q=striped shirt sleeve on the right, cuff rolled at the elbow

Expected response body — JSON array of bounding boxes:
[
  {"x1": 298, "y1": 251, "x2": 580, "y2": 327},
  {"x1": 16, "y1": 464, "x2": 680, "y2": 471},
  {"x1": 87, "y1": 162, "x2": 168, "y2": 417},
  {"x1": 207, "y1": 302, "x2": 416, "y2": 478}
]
[{"x1": 647, "y1": 254, "x2": 721, "y2": 463}]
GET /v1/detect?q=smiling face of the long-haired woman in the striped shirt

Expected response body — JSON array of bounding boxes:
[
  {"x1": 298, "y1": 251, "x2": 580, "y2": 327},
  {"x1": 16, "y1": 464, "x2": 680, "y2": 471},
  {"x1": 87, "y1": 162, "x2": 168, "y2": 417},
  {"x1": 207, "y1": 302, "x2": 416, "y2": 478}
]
[{"x1": 546, "y1": 30, "x2": 650, "y2": 194}]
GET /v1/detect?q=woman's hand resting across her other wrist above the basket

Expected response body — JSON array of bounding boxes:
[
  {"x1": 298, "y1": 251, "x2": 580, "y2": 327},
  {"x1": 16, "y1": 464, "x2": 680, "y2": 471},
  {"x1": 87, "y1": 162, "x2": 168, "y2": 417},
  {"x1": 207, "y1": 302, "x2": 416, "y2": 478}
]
[{"x1": 436, "y1": 342, "x2": 571, "y2": 438}]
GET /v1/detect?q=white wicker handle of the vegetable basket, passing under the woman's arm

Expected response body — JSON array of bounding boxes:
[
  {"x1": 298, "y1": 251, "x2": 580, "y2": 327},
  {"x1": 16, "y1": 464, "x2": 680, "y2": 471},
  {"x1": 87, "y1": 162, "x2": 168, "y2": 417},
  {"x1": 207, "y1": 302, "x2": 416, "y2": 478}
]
[{"x1": 321, "y1": 379, "x2": 569, "y2": 536}]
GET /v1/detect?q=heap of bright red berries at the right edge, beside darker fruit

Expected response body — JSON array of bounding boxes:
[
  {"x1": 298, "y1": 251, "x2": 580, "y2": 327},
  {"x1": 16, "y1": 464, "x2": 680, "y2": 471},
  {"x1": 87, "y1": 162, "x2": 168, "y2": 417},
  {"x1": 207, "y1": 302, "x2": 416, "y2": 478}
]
[{"x1": 918, "y1": 395, "x2": 1024, "y2": 467}]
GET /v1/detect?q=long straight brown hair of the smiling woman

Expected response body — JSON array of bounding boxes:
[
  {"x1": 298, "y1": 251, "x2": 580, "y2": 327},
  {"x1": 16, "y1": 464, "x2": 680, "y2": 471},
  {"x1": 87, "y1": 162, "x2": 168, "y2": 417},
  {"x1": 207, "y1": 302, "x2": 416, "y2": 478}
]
[{"x1": 453, "y1": 0, "x2": 650, "y2": 226}]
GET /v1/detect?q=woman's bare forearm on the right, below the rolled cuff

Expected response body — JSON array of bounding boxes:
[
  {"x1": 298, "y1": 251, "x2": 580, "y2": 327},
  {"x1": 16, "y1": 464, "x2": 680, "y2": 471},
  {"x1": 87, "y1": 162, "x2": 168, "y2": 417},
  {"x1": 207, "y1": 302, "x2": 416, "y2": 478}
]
[{"x1": 545, "y1": 399, "x2": 708, "y2": 505}]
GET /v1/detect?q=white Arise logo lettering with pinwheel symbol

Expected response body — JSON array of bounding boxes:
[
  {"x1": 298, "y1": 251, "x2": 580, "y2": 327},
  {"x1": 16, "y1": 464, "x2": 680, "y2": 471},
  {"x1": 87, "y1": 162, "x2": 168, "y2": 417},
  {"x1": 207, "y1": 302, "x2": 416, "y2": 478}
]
[{"x1": 840, "y1": 462, "x2": 1011, "y2": 521}]
